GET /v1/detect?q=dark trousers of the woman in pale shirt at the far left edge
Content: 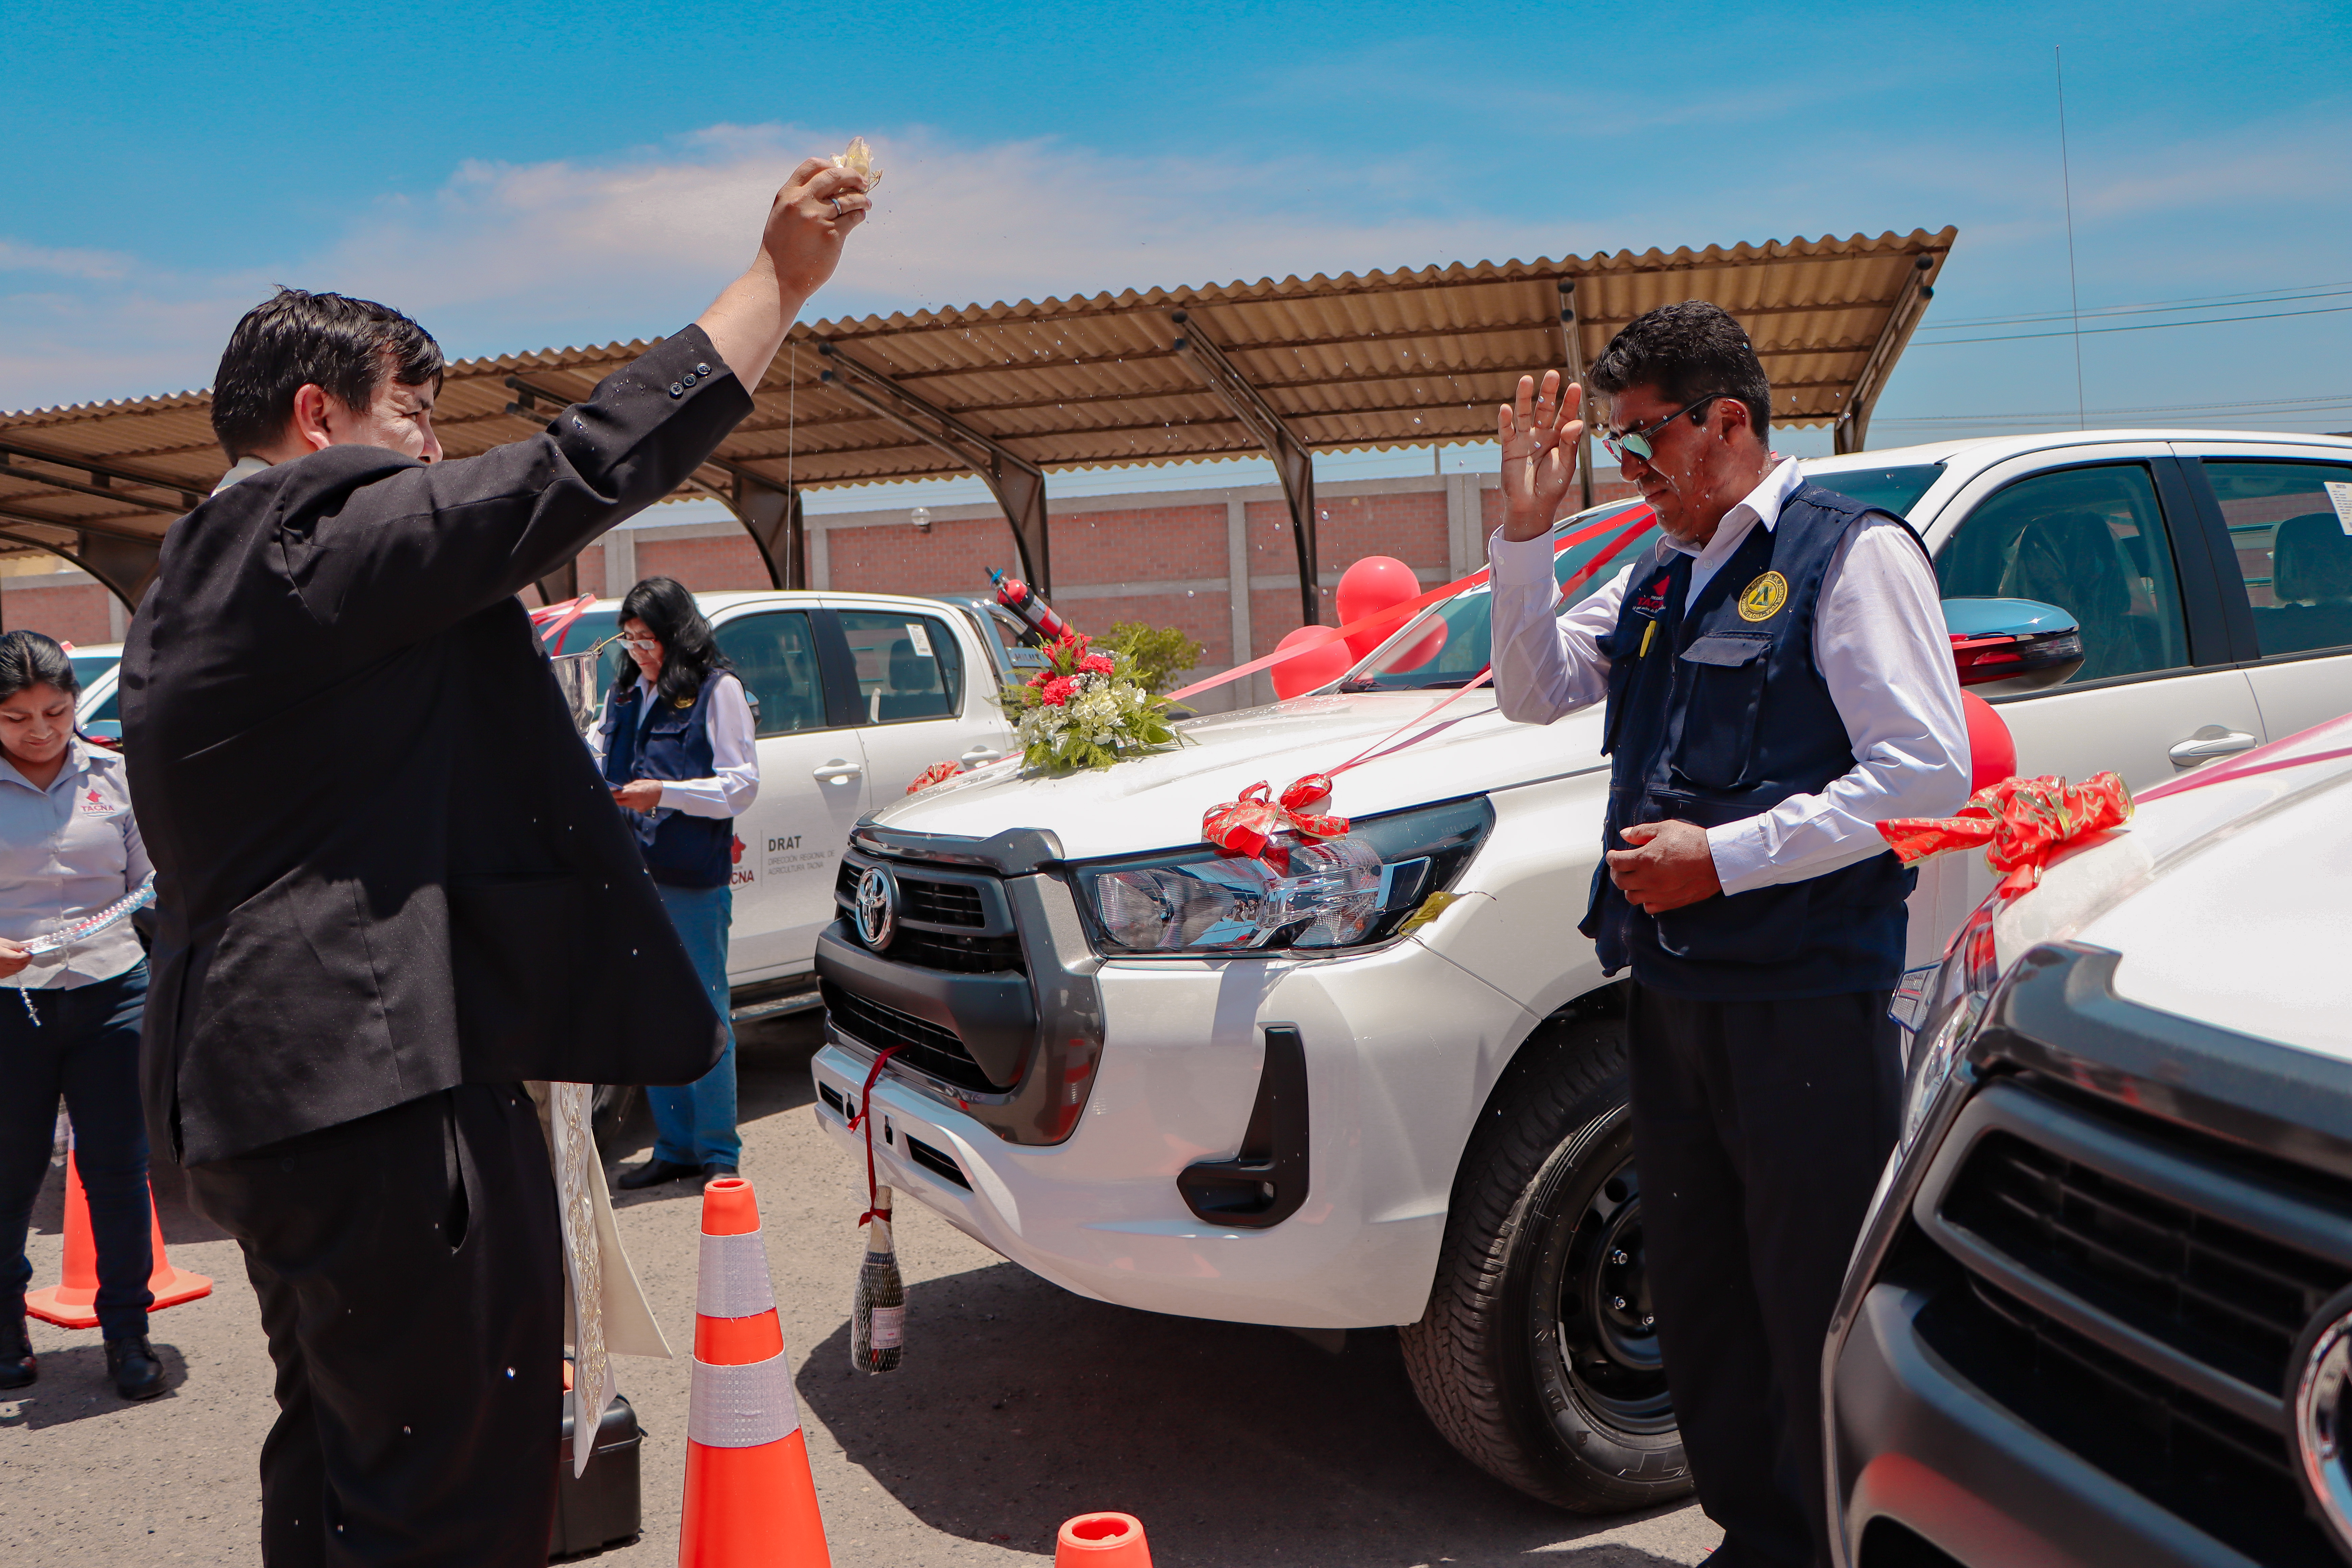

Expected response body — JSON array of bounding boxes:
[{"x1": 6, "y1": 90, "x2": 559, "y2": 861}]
[{"x1": 0, "y1": 961, "x2": 154, "y2": 1340}]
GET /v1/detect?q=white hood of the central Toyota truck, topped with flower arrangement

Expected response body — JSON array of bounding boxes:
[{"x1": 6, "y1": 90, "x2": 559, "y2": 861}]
[{"x1": 873, "y1": 689, "x2": 1607, "y2": 860}]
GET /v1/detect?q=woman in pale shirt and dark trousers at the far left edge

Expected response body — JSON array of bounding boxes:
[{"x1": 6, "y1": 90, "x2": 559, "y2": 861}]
[{"x1": 0, "y1": 632, "x2": 165, "y2": 1399}]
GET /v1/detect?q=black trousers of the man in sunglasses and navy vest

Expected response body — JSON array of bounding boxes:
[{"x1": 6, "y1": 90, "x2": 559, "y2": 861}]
[{"x1": 1627, "y1": 985, "x2": 1903, "y2": 1568}]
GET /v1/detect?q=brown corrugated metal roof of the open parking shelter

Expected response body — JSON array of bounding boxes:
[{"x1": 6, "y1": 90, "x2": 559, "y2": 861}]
[{"x1": 0, "y1": 228, "x2": 1957, "y2": 557}]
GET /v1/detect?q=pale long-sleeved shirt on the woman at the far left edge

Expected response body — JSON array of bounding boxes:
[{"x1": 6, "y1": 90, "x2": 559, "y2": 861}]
[{"x1": 0, "y1": 738, "x2": 155, "y2": 987}]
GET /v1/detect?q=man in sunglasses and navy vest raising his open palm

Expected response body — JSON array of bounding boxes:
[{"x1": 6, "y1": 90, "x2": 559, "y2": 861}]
[{"x1": 1489, "y1": 301, "x2": 1969, "y2": 1566}]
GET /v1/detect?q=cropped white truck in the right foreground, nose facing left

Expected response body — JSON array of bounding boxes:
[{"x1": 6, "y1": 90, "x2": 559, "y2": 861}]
[{"x1": 1825, "y1": 719, "x2": 2352, "y2": 1568}]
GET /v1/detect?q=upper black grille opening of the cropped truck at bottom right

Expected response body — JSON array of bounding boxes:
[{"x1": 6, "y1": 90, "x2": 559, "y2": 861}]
[{"x1": 1943, "y1": 1133, "x2": 2352, "y2": 1396}]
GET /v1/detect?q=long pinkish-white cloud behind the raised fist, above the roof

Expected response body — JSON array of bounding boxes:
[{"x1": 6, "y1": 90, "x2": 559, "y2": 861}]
[{"x1": 329, "y1": 127, "x2": 1609, "y2": 346}]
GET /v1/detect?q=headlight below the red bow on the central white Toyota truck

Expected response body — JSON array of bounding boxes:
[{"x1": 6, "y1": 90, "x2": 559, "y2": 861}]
[{"x1": 1075, "y1": 794, "x2": 1494, "y2": 957}]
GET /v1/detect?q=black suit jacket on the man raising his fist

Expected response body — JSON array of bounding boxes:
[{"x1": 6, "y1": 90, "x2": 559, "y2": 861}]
[{"x1": 122, "y1": 327, "x2": 753, "y2": 1161}]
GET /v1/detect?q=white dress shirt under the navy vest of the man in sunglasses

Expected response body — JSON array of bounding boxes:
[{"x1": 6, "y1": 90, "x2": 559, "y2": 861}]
[{"x1": 1487, "y1": 459, "x2": 1969, "y2": 893}]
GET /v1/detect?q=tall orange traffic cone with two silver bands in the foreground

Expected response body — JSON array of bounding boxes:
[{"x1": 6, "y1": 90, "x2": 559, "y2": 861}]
[{"x1": 677, "y1": 1175, "x2": 833, "y2": 1568}]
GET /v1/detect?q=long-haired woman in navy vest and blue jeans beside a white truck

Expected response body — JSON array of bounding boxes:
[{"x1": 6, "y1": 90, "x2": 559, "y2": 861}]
[{"x1": 593, "y1": 576, "x2": 760, "y2": 1190}]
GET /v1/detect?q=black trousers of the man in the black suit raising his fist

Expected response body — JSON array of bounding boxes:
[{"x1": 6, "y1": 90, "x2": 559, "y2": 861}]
[{"x1": 188, "y1": 1084, "x2": 564, "y2": 1568}]
